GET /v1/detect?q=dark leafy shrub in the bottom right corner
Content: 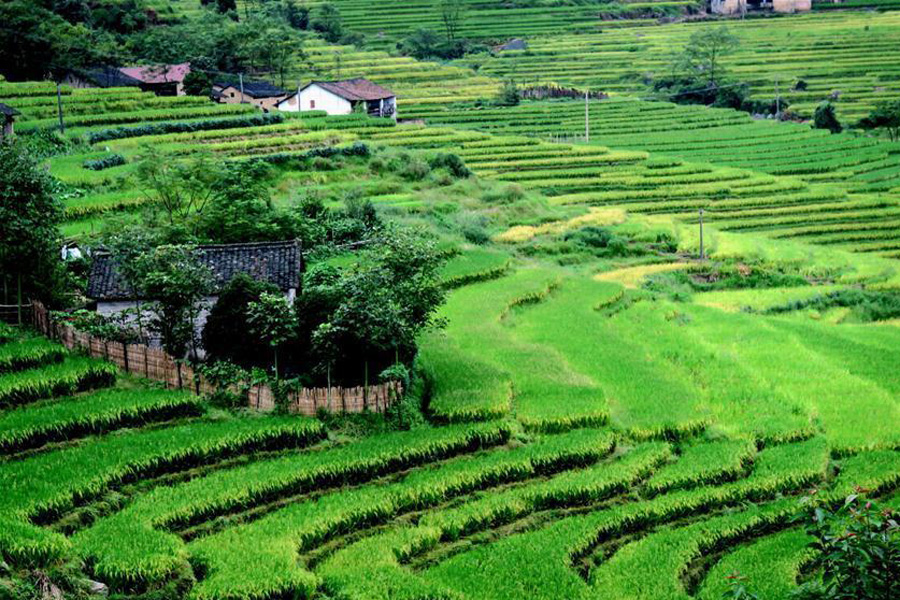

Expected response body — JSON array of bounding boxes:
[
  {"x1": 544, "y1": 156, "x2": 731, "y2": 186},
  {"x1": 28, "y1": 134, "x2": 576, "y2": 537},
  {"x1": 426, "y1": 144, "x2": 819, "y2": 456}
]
[{"x1": 794, "y1": 494, "x2": 900, "y2": 600}]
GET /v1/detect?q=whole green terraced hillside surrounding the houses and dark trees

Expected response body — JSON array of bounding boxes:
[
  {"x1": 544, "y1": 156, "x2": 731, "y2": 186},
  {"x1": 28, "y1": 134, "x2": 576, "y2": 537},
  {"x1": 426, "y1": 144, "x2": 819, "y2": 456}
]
[{"x1": 0, "y1": 0, "x2": 900, "y2": 600}]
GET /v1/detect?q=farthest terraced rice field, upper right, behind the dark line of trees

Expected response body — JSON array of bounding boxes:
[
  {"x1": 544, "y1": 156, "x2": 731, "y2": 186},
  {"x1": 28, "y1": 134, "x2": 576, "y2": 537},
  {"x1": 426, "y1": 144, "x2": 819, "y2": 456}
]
[{"x1": 458, "y1": 12, "x2": 900, "y2": 122}]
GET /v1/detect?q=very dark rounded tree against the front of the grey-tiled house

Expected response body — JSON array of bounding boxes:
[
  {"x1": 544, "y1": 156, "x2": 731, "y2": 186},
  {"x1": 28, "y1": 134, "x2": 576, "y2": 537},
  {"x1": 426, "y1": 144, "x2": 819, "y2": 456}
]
[{"x1": 203, "y1": 273, "x2": 278, "y2": 368}]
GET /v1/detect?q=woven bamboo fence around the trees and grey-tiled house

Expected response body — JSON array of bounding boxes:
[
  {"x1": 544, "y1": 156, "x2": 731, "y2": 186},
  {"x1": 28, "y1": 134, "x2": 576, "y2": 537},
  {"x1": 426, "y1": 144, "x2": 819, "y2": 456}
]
[{"x1": 30, "y1": 302, "x2": 403, "y2": 416}]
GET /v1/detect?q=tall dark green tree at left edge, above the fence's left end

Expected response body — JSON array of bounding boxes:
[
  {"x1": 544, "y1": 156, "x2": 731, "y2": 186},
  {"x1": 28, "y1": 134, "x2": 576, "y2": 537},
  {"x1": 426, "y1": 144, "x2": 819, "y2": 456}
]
[{"x1": 0, "y1": 138, "x2": 63, "y2": 314}]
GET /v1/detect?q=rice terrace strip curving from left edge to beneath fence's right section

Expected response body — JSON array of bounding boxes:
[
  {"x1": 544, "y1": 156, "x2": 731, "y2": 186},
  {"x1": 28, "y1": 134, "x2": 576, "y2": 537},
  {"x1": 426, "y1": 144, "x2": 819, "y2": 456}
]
[{"x1": 0, "y1": 417, "x2": 324, "y2": 564}]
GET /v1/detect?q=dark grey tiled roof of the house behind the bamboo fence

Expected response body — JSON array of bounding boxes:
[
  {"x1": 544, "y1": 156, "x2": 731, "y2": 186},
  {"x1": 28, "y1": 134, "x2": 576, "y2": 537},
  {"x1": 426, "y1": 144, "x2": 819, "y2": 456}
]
[{"x1": 87, "y1": 240, "x2": 302, "y2": 301}]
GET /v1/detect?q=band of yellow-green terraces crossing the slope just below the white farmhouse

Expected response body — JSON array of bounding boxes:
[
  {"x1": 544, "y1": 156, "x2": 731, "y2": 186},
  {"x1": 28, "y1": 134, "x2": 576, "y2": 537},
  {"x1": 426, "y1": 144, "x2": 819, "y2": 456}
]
[{"x1": 10, "y1": 75, "x2": 900, "y2": 257}]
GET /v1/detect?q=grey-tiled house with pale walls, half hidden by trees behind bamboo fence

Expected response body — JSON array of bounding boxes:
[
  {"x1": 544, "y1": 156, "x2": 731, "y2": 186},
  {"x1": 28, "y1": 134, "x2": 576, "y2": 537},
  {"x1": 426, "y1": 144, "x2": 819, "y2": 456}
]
[{"x1": 87, "y1": 240, "x2": 303, "y2": 356}]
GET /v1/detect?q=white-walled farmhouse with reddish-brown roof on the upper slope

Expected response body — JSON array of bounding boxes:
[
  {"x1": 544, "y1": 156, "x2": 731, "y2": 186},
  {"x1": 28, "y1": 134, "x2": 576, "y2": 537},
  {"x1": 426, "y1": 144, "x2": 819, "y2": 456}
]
[{"x1": 276, "y1": 78, "x2": 397, "y2": 119}]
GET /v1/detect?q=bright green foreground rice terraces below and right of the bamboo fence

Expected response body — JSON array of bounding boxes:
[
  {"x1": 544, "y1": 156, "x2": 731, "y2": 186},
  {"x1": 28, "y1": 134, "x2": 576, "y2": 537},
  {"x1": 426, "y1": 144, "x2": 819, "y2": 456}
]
[{"x1": 0, "y1": 239, "x2": 900, "y2": 600}]
